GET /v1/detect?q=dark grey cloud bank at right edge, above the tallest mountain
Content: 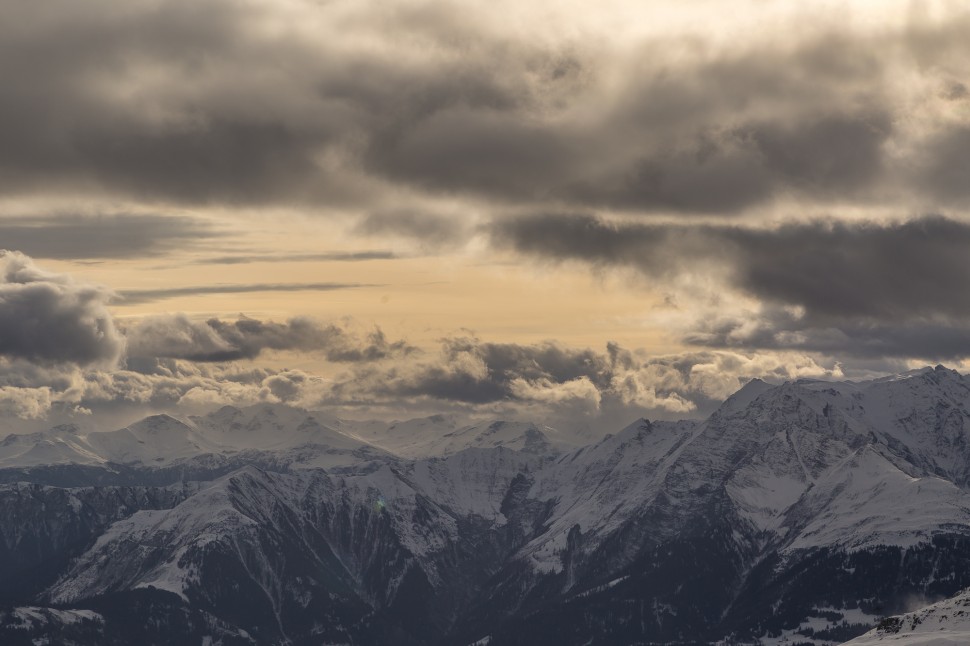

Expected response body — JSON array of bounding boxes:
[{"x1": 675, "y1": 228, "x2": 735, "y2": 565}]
[{"x1": 491, "y1": 214, "x2": 970, "y2": 358}]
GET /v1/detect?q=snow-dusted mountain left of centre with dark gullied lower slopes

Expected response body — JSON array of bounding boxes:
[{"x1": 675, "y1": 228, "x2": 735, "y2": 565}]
[{"x1": 45, "y1": 449, "x2": 534, "y2": 643}]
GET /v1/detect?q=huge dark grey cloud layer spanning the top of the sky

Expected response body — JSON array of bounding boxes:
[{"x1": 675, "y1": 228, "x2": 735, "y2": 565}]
[{"x1": 0, "y1": 0, "x2": 970, "y2": 214}]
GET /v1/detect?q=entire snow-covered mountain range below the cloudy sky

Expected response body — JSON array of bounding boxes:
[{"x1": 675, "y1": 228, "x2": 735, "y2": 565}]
[{"x1": 0, "y1": 366, "x2": 970, "y2": 646}]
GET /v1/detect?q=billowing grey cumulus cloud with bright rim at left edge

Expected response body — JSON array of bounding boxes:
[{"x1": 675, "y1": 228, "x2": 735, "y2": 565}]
[{"x1": 0, "y1": 251, "x2": 124, "y2": 365}]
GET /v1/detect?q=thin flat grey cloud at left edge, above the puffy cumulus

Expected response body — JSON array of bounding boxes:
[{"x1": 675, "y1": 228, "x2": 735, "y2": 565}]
[{"x1": 0, "y1": 213, "x2": 220, "y2": 260}]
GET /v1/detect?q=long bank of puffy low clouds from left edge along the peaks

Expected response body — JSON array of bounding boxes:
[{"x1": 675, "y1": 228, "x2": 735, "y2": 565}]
[{"x1": 0, "y1": 252, "x2": 876, "y2": 423}]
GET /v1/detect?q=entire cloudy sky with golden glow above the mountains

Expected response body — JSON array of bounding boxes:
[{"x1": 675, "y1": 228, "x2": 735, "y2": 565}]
[{"x1": 0, "y1": 0, "x2": 970, "y2": 430}]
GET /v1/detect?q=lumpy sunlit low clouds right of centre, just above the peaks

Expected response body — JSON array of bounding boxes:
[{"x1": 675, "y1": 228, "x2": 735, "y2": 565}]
[{"x1": 321, "y1": 337, "x2": 841, "y2": 424}]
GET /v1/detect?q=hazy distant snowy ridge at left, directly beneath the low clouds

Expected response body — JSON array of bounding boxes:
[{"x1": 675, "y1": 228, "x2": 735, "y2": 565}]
[{"x1": 0, "y1": 404, "x2": 577, "y2": 469}]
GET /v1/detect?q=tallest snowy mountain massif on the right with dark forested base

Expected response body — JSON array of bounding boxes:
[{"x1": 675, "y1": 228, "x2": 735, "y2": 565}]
[{"x1": 454, "y1": 368, "x2": 970, "y2": 644}]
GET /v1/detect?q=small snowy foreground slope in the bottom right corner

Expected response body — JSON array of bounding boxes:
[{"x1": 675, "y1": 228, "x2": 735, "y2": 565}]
[{"x1": 846, "y1": 592, "x2": 970, "y2": 646}]
